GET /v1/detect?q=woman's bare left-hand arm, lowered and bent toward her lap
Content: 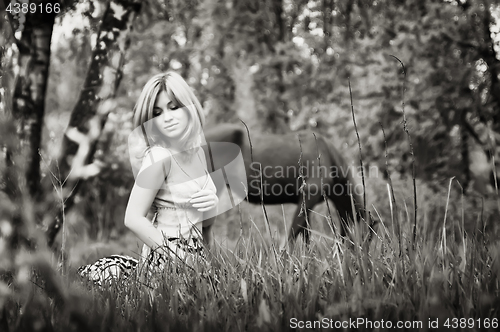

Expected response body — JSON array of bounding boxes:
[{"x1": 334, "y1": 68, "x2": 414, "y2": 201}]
[{"x1": 125, "y1": 148, "x2": 170, "y2": 249}]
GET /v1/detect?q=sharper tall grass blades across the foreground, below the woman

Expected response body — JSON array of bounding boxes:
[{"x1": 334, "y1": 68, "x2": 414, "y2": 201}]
[{"x1": 3, "y1": 192, "x2": 500, "y2": 331}]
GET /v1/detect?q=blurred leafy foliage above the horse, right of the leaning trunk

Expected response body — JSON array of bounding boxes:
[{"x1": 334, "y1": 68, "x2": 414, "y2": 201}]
[{"x1": 42, "y1": 0, "x2": 498, "y2": 195}]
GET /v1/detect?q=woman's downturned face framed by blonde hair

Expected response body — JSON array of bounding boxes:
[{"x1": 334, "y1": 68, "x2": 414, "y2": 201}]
[{"x1": 153, "y1": 91, "x2": 189, "y2": 143}]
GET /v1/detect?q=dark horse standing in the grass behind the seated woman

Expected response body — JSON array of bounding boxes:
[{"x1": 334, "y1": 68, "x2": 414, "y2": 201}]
[{"x1": 205, "y1": 124, "x2": 364, "y2": 241}]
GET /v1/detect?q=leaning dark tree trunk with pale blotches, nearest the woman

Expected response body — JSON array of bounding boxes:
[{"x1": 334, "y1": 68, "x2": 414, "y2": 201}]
[{"x1": 47, "y1": 0, "x2": 141, "y2": 246}]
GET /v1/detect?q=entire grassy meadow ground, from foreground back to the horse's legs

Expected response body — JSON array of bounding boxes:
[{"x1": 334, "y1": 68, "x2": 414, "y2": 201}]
[{"x1": 0, "y1": 162, "x2": 500, "y2": 331}]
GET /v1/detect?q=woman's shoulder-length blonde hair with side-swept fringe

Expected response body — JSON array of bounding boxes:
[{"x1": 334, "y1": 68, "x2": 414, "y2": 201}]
[{"x1": 133, "y1": 72, "x2": 205, "y2": 152}]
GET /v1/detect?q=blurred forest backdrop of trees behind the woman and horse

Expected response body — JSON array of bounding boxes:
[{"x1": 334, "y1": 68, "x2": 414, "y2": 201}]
[{"x1": 0, "y1": 0, "x2": 500, "y2": 290}]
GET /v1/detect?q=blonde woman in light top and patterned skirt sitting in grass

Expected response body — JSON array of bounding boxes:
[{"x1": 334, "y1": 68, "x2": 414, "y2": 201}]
[{"x1": 79, "y1": 72, "x2": 218, "y2": 283}]
